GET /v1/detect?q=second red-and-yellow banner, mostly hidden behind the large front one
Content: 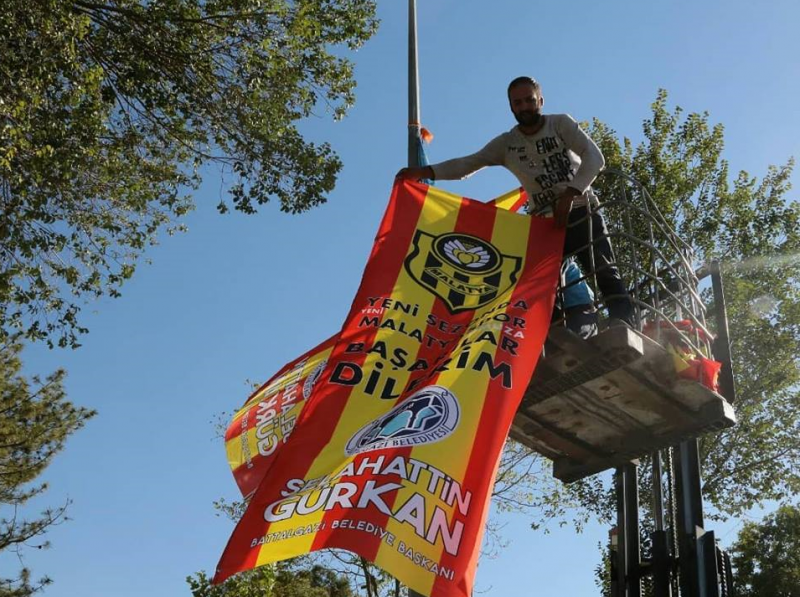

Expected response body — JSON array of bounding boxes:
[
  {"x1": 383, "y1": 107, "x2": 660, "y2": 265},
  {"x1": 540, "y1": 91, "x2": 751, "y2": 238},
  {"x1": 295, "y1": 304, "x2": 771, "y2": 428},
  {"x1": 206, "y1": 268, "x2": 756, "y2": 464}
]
[{"x1": 225, "y1": 187, "x2": 528, "y2": 499}]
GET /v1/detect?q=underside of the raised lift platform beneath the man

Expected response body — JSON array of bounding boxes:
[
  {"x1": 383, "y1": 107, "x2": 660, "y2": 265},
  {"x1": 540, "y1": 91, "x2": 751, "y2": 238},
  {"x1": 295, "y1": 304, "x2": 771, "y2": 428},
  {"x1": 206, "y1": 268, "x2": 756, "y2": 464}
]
[{"x1": 511, "y1": 327, "x2": 736, "y2": 483}]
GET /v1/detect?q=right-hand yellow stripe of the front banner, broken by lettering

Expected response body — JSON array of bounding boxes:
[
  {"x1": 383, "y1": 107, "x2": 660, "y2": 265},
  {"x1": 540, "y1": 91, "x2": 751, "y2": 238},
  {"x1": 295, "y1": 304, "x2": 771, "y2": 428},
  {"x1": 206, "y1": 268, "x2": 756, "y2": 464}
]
[{"x1": 376, "y1": 201, "x2": 530, "y2": 594}]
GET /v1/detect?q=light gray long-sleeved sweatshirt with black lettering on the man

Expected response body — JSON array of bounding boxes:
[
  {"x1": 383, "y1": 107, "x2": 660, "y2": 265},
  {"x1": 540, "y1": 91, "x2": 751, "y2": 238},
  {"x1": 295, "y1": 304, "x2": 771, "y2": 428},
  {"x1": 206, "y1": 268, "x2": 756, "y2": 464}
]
[{"x1": 431, "y1": 114, "x2": 605, "y2": 215}]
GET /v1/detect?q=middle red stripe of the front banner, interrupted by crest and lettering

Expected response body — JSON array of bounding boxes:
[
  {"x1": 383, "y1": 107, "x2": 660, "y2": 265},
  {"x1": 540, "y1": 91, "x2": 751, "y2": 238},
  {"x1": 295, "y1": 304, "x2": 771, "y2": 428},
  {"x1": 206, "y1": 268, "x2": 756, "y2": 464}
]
[{"x1": 312, "y1": 193, "x2": 497, "y2": 561}]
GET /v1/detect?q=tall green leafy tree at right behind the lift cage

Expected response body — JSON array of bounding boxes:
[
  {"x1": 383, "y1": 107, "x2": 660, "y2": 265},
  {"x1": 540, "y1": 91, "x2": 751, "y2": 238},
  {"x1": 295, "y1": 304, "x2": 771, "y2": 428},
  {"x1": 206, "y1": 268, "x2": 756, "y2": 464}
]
[{"x1": 592, "y1": 90, "x2": 800, "y2": 517}]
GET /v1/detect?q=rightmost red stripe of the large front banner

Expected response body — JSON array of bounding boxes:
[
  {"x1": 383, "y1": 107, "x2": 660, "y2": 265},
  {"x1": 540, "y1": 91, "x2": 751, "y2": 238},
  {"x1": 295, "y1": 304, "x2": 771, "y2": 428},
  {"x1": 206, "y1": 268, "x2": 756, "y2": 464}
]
[{"x1": 431, "y1": 218, "x2": 564, "y2": 597}]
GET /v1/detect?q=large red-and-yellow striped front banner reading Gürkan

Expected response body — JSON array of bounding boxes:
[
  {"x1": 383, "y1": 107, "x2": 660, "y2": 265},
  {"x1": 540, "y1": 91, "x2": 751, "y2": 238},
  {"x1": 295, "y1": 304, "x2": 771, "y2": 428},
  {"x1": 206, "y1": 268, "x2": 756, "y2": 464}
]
[{"x1": 215, "y1": 182, "x2": 563, "y2": 597}]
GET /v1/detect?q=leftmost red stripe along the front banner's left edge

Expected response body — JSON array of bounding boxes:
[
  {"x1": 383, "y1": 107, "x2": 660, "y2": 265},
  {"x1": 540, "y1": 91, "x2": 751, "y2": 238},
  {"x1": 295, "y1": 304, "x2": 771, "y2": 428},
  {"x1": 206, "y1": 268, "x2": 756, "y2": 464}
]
[{"x1": 213, "y1": 184, "x2": 427, "y2": 583}]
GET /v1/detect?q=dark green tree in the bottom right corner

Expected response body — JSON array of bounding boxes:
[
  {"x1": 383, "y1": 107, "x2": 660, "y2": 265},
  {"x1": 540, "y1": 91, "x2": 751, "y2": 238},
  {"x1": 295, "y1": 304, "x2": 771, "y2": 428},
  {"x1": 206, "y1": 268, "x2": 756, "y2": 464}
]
[{"x1": 731, "y1": 506, "x2": 800, "y2": 597}]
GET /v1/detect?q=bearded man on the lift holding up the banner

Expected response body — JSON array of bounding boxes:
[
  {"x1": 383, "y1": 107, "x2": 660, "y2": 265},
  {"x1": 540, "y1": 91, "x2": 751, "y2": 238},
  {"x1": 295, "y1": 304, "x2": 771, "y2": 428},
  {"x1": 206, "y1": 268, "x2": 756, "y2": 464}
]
[{"x1": 397, "y1": 77, "x2": 634, "y2": 326}]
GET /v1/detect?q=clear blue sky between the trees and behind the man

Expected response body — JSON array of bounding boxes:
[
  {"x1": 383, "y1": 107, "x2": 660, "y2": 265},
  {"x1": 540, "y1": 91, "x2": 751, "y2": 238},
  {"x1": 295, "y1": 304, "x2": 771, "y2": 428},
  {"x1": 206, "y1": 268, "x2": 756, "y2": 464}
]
[{"x1": 9, "y1": 0, "x2": 800, "y2": 597}]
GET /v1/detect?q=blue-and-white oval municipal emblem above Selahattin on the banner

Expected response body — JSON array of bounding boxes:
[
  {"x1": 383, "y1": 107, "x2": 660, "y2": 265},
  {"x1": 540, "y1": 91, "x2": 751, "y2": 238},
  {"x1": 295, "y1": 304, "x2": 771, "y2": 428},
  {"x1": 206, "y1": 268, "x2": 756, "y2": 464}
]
[{"x1": 345, "y1": 386, "x2": 461, "y2": 456}]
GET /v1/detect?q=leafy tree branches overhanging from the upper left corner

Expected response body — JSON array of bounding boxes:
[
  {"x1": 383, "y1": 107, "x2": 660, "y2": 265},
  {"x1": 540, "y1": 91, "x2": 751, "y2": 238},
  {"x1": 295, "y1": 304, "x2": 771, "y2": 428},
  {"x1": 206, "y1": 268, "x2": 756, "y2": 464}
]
[{"x1": 0, "y1": 0, "x2": 377, "y2": 346}]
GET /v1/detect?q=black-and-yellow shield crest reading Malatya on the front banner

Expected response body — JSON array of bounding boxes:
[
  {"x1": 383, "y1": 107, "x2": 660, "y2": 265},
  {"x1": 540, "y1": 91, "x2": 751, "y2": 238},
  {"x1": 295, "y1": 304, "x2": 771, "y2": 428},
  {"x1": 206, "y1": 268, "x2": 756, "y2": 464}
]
[{"x1": 405, "y1": 230, "x2": 522, "y2": 313}]
